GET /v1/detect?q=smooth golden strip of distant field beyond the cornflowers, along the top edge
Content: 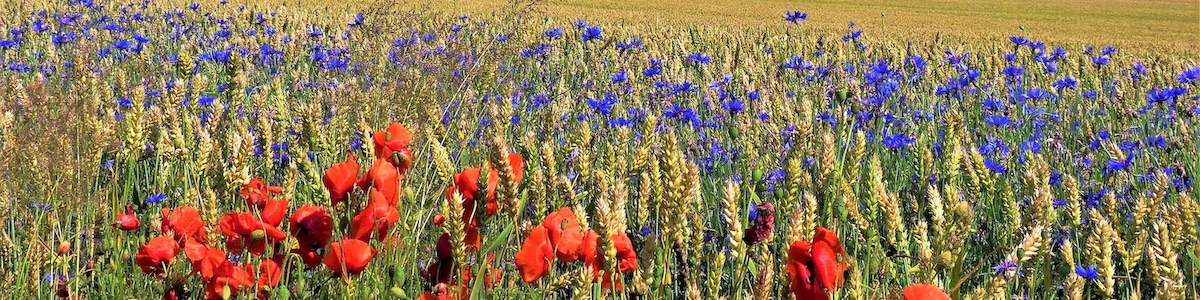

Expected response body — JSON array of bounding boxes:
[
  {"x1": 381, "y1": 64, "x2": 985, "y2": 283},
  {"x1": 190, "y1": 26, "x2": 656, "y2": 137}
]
[{"x1": 410, "y1": 0, "x2": 1200, "y2": 56}]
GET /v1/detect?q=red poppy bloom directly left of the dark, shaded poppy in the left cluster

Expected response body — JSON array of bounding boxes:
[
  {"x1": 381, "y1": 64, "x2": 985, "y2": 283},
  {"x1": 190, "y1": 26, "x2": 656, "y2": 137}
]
[{"x1": 218, "y1": 212, "x2": 288, "y2": 256}]
